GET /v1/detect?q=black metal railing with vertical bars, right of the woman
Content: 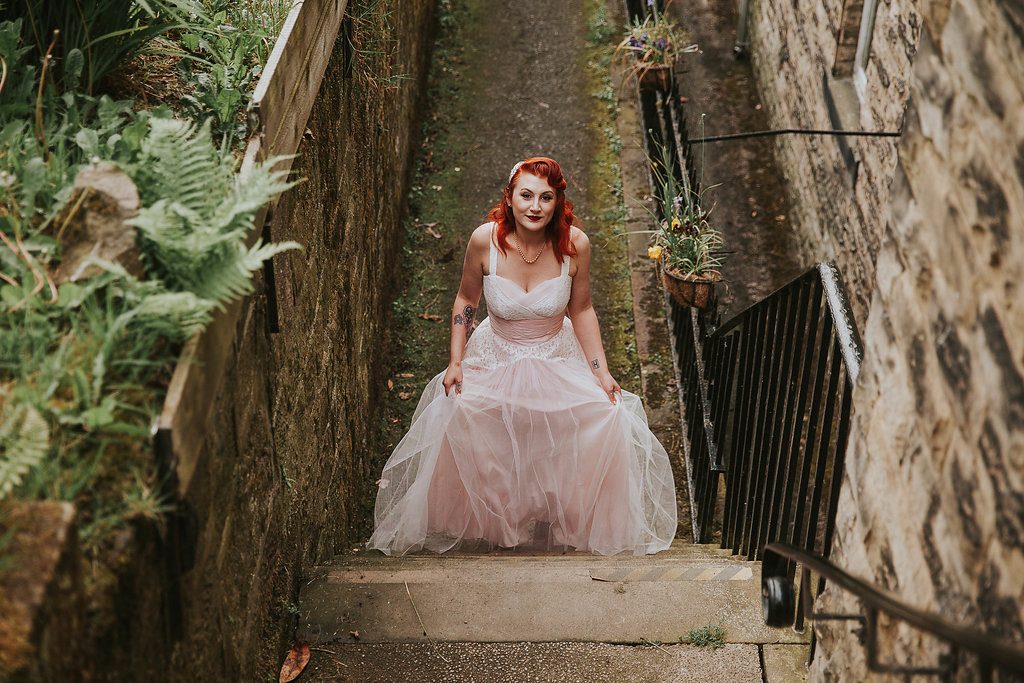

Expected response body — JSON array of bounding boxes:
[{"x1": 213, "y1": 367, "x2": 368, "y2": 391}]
[{"x1": 627, "y1": 1, "x2": 860, "y2": 593}]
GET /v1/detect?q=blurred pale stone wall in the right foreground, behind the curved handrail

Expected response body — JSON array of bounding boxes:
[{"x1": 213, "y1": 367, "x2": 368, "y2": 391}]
[{"x1": 812, "y1": 0, "x2": 1024, "y2": 681}]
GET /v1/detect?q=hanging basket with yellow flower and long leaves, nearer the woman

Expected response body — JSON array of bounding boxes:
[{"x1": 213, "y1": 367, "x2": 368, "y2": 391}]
[{"x1": 647, "y1": 140, "x2": 723, "y2": 309}]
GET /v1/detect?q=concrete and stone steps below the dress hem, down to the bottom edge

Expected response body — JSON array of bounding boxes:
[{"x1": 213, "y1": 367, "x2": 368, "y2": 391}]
[{"x1": 298, "y1": 541, "x2": 807, "y2": 683}]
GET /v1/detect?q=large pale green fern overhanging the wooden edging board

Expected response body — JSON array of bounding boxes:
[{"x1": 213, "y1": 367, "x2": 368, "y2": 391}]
[{"x1": 131, "y1": 119, "x2": 301, "y2": 307}]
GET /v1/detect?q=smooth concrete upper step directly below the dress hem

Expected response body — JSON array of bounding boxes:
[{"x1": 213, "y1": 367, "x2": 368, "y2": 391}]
[{"x1": 298, "y1": 544, "x2": 804, "y2": 644}]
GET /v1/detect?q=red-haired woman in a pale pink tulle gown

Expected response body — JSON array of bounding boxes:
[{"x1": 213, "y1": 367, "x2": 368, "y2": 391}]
[{"x1": 367, "y1": 157, "x2": 676, "y2": 555}]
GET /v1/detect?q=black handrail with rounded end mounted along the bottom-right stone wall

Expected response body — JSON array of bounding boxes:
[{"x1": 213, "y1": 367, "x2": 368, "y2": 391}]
[{"x1": 761, "y1": 543, "x2": 1024, "y2": 678}]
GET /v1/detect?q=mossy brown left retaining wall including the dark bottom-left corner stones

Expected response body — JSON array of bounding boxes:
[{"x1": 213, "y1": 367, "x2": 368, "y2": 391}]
[{"x1": 0, "y1": 0, "x2": 435, "y2": 683}]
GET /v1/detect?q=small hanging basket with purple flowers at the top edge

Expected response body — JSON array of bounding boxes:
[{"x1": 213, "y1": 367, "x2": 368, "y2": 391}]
[{"x1": 615, "y1": 0, "x2": 697, "y2": 91}]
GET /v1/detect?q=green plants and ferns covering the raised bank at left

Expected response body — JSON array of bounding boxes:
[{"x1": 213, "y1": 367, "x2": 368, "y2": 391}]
[{"x1": 0, "y1": 0, "x2": 298, "y2": 551}]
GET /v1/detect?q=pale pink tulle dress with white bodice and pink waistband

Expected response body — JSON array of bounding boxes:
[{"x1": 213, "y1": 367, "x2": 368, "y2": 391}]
[{"x1": 367, "y1": 224, "x2": 676, "y2": 555}]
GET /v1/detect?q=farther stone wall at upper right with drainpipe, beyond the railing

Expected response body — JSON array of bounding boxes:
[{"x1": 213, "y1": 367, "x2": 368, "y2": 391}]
[{"x1": 749, "y1": 0, "x2": 921, "y2": 329}]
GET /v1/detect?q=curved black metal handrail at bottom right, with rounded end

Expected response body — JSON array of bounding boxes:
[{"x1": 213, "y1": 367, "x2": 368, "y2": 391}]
[{"x1": 761, "y1": 543, "x2": 1024, "y2": 681}]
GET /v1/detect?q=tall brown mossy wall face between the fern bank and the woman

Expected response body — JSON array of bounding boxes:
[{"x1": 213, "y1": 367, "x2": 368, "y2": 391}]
[{"x1": 159, "y1": 0, "x2": 434, "y2": 681}]
